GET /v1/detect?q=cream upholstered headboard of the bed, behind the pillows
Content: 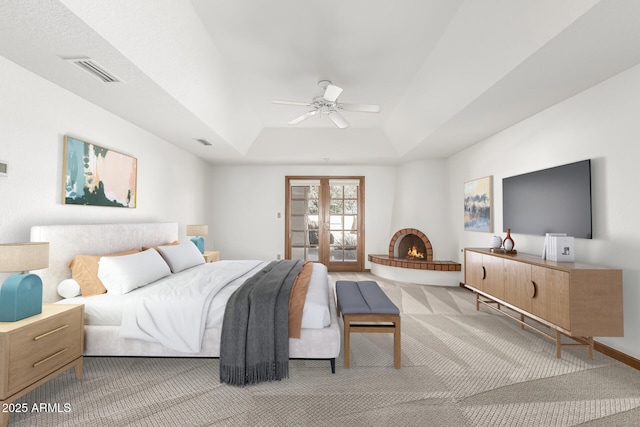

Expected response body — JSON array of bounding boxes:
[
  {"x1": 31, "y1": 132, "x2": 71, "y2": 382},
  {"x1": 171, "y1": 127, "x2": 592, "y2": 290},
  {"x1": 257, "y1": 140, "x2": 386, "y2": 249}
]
[{"x1": 31, "y1": 222, "x2": 178, "y2": 302}]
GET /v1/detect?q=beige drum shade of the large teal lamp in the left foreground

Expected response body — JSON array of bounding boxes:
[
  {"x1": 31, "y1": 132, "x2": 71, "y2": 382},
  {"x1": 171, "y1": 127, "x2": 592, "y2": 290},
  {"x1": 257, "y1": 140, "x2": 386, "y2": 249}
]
[{"x1": 0, "y1": 242, "x2": 49, "y2": 273}]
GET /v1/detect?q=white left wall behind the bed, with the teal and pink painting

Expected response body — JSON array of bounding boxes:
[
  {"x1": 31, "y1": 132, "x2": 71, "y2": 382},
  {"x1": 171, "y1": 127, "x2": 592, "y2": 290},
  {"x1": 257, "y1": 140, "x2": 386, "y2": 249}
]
[{"x1": 0, "y1": 57, "x2": 210, "y2": 281}]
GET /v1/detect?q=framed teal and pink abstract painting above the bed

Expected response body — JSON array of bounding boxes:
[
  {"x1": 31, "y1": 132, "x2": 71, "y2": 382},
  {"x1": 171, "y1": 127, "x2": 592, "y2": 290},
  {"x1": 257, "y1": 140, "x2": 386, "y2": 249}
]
[{"x1": 62, "y1": 136, "x2": 138, "y2": 208}]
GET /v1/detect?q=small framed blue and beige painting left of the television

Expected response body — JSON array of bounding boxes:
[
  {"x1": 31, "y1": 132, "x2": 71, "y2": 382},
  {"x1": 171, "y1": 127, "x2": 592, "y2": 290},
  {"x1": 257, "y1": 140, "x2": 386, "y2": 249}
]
[{"x1": 464, "y1": 176, "x2": 493, "y2": 233}]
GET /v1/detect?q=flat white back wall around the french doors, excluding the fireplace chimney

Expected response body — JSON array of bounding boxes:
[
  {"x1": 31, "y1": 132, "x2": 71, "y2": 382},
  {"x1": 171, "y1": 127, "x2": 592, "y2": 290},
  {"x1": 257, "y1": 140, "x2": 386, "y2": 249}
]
[{"x1": 207, "y1": 165, "x2": 396, "y2": 268}]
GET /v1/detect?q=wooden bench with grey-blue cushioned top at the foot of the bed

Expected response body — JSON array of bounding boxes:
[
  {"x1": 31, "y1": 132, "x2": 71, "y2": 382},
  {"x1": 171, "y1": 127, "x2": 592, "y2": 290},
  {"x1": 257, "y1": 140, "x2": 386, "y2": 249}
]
[{"x1": 336, "y1": 280, "x2": 400, "y2": 369}]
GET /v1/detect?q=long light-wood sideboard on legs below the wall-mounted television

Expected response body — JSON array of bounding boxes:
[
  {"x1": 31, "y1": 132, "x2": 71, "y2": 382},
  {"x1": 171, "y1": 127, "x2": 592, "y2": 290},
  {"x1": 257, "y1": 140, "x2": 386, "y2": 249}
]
[{"x1": 464, "y1": 248, "x2": 624, "y2": 358}]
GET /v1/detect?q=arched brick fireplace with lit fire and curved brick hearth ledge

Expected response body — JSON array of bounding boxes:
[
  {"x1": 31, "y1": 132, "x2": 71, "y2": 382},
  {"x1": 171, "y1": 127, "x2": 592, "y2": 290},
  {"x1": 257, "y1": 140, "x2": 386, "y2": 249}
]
[{"x1": 369, "y1": 228, "x2": 462, "y2": 271}]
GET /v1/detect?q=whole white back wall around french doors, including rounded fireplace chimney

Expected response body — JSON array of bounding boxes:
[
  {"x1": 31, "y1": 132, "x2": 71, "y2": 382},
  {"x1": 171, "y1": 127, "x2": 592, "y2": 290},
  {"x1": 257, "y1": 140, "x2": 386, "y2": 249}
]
[{"x1": 208, "y1": 160, "x2": 458, "y2": 268}]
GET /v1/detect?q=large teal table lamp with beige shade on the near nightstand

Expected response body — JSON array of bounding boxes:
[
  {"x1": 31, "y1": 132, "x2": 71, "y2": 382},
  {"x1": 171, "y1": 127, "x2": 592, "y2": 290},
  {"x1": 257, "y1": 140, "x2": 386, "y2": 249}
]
[{"x1": 0, "y1": 242, "x2": 49, "y2": 322}]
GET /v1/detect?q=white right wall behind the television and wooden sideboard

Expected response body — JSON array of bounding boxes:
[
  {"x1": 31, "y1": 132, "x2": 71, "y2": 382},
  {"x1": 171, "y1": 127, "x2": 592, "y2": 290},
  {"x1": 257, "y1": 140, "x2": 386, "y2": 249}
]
[{"x1": 448, "y1": 61, "x2": 640, "y2": 358}]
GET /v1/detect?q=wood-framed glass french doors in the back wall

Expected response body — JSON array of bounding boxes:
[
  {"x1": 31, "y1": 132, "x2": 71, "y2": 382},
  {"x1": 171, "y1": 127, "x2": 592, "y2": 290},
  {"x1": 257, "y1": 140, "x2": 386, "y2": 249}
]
[{"x1": 285, "y1": 177, "x2": 364, "y2": 271}]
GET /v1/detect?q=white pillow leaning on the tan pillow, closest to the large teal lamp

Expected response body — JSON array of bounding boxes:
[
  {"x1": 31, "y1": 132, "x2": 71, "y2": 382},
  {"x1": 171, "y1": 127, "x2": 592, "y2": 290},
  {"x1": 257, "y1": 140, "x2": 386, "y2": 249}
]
[{"x1": 98, "y1": 249, "x2": 171, "y2": 295}]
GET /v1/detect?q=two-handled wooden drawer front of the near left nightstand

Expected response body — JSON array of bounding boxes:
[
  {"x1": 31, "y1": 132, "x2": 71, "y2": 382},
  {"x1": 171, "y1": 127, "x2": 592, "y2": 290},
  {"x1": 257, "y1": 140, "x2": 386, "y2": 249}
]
[{"x1": 8, "y1": 308, "x2": 84, "y2": 394}]
